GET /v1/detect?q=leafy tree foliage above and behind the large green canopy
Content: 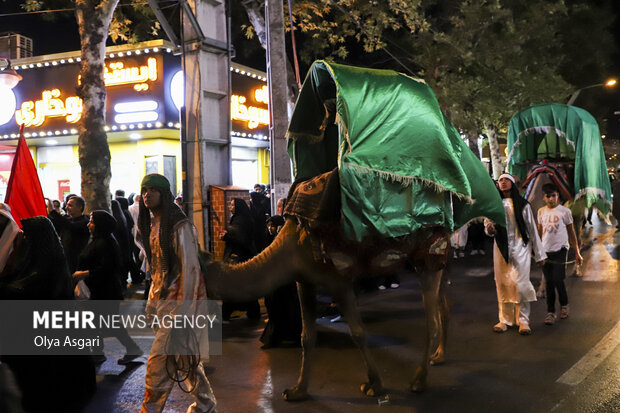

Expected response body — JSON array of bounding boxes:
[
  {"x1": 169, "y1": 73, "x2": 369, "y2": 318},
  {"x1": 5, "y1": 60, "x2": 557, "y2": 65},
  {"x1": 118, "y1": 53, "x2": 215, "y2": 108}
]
[{"x1": 239, "y1": 0, "x2": 613, "y2": 175}]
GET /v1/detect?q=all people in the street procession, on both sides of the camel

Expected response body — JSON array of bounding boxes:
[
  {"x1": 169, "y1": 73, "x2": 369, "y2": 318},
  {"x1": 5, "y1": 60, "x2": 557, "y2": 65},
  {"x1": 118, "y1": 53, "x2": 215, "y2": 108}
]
[{"x1": 0, "y1": 169, "x2": 620, "y2": 412}]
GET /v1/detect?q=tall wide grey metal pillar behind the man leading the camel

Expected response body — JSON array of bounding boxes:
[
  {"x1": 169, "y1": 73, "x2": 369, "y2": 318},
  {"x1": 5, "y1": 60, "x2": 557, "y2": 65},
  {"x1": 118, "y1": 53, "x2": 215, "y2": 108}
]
[{"x1": 180, "y1": 0, "x2": 231, "y2": 249}]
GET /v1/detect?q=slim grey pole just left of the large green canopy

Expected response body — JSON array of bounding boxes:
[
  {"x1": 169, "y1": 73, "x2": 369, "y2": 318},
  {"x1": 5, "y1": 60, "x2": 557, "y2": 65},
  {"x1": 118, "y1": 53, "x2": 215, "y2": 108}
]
[{"x1": 265, "y1": 0, "x2": 291, "y2": 209}]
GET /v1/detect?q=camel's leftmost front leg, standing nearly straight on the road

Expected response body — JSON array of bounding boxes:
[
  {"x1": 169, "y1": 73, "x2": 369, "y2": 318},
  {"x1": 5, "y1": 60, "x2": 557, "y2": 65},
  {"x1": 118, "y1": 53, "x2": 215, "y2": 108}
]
[{"x1": 282, "y1": 282, "x2": 316, "y2": 401}]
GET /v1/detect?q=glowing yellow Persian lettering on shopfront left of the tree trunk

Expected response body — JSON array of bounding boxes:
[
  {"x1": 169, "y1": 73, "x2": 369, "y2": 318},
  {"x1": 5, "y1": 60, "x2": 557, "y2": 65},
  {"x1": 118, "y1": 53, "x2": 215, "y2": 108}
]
[{"x1": 15, "y1": 89, "x2": 82, "y2": 126}]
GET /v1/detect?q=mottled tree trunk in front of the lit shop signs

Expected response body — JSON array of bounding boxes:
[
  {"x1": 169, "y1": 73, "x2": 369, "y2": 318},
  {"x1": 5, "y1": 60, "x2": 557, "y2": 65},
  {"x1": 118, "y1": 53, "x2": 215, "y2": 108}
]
[{"x1": 75, "y1": 0, "x2": 119, "y2": 211}]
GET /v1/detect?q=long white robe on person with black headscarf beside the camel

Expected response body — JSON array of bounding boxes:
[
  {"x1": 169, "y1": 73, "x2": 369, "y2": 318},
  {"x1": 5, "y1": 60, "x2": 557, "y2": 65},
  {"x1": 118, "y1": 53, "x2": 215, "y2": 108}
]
[{"x1": 493, "y1": 198, "x2": 547, "y2": 303}]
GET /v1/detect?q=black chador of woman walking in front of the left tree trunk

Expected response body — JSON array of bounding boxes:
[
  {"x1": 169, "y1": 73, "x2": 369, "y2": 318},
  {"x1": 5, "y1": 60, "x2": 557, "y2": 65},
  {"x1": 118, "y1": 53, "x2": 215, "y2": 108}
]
[{"x1": 78, "y1": 211, "x2": 123, "y2": 300}]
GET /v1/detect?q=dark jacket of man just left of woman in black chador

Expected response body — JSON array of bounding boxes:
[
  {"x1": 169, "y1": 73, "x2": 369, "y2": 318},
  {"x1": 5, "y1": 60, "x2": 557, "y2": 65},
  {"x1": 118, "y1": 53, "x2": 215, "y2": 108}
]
[{"x1": 49, "y1": 211, "x2": 90, "y2": 274}]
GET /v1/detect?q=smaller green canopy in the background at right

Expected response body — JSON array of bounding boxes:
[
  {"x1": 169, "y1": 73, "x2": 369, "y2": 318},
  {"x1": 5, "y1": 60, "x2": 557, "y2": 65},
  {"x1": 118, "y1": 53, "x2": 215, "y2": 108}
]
[{"x1": 507, "y1": 103, "x2": 611, "y2": 214}]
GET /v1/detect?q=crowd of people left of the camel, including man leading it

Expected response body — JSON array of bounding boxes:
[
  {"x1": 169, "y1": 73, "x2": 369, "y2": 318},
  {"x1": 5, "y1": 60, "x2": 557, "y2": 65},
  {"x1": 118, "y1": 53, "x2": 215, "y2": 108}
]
[{"x1": 0, "y1": 178, "x2": 301, "y2": 412}]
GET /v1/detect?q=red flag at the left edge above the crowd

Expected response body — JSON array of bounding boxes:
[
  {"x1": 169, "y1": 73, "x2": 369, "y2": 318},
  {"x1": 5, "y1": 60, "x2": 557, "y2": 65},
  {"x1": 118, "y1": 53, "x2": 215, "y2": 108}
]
[{"x1": 4, "y1": 125, "x2": 47, "y2": 228}]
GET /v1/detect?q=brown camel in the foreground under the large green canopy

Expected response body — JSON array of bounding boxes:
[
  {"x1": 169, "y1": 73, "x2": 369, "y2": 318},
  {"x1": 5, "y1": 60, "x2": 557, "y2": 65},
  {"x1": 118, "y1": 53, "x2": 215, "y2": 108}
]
[{"x1": 202, "y1": 212, "x2": 449, "y2": 401}]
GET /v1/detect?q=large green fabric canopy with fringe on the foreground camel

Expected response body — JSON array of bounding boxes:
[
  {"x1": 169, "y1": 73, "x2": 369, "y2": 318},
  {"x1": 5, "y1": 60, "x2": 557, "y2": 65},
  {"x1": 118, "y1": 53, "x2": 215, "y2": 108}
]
[{"x1": 287, "y1": 61, "x2": 505, "y2": 241}]
